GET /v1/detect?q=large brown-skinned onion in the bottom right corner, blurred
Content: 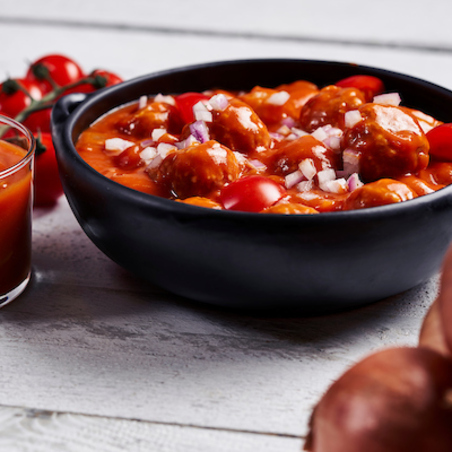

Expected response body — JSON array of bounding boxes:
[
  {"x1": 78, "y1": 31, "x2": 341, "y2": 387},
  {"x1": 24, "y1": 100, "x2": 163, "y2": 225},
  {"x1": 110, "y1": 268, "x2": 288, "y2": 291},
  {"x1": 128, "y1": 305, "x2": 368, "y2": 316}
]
[{"x1": 304, "y1": 347, "x2": 452, "y2": 452}]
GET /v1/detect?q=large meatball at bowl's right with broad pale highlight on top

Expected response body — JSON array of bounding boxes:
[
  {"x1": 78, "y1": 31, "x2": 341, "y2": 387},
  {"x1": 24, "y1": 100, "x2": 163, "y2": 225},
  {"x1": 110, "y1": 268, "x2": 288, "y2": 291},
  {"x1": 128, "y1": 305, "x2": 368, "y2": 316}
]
[{"x1": 342, "y1": 104, "x2": 429, "y2": 182}]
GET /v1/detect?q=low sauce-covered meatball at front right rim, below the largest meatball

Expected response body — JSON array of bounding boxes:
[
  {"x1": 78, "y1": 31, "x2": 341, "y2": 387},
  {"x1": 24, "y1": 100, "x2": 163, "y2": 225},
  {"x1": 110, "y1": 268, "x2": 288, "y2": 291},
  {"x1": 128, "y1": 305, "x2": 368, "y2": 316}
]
[{"x1": 343, "y1": 179, "x2": 416, "y2": 210}]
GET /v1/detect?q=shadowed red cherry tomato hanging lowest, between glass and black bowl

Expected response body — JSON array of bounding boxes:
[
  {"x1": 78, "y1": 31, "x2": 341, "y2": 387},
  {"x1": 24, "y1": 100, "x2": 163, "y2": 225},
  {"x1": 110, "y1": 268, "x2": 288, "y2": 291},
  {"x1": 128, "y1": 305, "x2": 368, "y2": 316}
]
[{"x1": 34, "y1": 133, "x2": 63, "y2": 207}]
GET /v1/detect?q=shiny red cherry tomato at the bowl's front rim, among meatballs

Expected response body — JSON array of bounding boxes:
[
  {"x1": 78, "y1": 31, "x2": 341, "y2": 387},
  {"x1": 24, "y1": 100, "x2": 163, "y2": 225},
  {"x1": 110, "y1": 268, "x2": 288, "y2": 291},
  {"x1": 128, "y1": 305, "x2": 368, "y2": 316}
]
[{"x1": 220, "y1": 176, "x2": 286, "y2": 212}]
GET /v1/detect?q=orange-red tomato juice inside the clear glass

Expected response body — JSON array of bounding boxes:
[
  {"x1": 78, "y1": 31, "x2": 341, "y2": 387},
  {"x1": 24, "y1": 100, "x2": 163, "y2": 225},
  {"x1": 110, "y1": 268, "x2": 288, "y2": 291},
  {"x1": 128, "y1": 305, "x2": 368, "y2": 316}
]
[{"x1": 0, "y1": 140, "x2": 32, "y2": 301}]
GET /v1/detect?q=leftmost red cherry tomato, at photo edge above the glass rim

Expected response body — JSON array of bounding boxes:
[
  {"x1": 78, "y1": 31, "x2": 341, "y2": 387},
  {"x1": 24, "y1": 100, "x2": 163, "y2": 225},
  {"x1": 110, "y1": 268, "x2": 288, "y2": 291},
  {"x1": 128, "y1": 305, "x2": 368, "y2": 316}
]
[{"x1": 0, "y1": 79, "x2": 42, "y2": 118}]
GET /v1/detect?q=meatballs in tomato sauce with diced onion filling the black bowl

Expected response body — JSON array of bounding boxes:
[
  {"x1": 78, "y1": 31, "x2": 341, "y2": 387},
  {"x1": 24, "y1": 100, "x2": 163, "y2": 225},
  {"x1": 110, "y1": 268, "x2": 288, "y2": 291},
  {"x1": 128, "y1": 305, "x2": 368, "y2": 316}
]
[{"x1": 76, "y1": 76, "x2": 452, "y2": 214}]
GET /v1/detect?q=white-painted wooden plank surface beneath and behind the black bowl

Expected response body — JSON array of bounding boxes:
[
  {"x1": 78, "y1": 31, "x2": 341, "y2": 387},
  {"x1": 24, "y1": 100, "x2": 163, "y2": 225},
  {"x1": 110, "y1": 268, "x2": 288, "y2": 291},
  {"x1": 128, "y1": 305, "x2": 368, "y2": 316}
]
[{"x1": 0, "y1": 0, "x2": 452, "y2": 452}]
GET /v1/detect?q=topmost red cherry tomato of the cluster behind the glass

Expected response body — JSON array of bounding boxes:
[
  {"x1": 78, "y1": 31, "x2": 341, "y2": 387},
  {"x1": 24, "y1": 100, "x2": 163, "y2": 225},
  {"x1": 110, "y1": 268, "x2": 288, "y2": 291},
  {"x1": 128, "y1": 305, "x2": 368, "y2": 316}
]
[{"x1": 26, "y1": 55, "x2": 85, "y2": 94}]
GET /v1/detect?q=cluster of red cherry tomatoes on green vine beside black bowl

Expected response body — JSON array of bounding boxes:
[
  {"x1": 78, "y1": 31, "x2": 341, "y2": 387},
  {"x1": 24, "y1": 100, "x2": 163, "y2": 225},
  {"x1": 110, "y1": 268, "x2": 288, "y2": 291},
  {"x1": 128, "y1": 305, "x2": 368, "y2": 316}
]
[{"x1": 0, "y1": 55, "x2": 122, "y2": 206}]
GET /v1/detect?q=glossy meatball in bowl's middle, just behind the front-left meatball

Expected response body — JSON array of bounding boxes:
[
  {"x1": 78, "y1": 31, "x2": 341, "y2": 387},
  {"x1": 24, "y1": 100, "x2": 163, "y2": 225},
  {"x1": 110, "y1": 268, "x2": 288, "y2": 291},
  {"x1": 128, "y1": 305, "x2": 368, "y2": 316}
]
[{"x1": 209, "y1": 98, "x2": 271, "y2": 154}]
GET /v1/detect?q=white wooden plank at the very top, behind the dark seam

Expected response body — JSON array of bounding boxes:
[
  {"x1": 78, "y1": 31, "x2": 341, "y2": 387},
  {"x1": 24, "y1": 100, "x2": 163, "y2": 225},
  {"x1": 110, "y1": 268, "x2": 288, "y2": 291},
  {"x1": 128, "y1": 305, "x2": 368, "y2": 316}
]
[{"x1": 2, "y1": 0, "x2": 452, "y2": 51}]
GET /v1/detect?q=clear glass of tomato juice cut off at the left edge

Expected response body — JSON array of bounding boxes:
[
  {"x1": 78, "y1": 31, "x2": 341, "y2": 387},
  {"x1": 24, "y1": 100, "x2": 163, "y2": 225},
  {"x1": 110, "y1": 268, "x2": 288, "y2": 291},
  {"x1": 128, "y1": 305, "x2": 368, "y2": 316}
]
[{"x1": 0, "y1": 115, "x2": 35, "y2": 308}]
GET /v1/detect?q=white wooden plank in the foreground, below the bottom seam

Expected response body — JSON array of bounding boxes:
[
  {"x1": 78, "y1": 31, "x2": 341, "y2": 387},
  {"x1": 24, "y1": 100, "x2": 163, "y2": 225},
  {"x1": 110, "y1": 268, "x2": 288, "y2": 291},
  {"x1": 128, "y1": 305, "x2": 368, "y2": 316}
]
[{"x1": 0, "y1": 406, "x2": 302, "y2": 452}]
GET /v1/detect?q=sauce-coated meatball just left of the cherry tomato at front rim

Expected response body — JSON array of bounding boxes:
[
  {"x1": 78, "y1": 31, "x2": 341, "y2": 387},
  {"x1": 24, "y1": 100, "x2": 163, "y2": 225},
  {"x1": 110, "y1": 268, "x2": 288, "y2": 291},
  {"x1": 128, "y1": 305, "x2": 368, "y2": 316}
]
[{"x1": 156, "y1": 140, "x2": 240, "y2": 199}]
